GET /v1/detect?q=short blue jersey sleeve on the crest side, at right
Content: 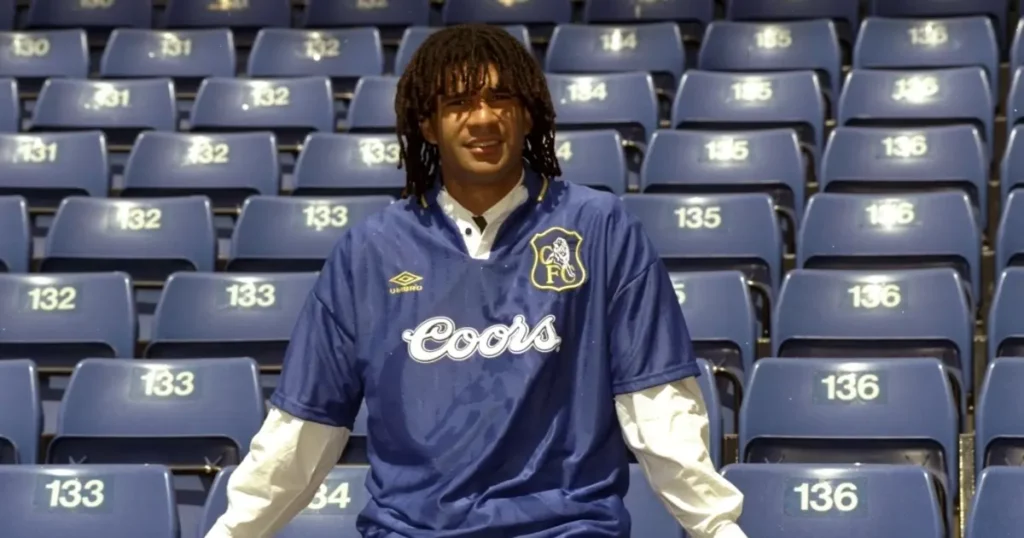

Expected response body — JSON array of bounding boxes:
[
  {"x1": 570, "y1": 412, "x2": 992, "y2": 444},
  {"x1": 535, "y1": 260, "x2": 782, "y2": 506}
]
[{"x1": 608, "y1": 205, "x2": 700, "y2": 396}]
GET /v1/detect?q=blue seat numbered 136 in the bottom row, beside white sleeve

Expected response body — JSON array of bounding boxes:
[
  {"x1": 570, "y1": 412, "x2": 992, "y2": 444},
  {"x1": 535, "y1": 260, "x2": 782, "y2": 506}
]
[{"x1": 724, "y1": 463, "x2": 949, "y2": 538}]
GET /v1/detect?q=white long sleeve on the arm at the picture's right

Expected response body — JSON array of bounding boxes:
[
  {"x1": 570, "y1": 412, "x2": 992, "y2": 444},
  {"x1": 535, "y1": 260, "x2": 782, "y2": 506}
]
[{"x1": 615, "y1": 377, "x2": 746, "y2": 538}]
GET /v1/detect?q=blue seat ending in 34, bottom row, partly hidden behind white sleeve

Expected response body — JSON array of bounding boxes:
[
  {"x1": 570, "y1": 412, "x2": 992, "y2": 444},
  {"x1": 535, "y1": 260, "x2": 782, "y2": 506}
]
[{"x1": 200, "y1": 465, "x2": 370, "y2": 538}]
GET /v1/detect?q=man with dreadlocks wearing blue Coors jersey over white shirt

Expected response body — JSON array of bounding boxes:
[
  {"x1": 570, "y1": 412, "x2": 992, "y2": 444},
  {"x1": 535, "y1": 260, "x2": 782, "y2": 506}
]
[{"x1": 208, "y1": 25, "x2": 744, "y2": 538}]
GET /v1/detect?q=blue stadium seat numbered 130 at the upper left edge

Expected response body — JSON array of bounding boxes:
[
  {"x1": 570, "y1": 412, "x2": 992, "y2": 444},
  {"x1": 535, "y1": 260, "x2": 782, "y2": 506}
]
[{"x1": 0, "y1": 30, "x2": 89, "y2": 92}]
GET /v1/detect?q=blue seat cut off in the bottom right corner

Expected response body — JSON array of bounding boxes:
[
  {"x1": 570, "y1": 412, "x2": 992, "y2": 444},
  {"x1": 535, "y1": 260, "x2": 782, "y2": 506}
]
[{"x1": 965, "y1": 466, "x2": 1024, "y2": 538}]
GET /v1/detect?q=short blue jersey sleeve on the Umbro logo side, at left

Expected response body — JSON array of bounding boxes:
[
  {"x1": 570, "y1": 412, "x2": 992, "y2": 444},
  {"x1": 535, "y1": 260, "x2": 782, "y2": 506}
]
[{"x1": 270, "y1": 236, "x2": 362, "y2": 429}]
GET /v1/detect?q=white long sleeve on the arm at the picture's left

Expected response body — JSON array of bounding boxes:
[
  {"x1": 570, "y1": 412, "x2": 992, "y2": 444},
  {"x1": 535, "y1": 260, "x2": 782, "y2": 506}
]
[{"x1": 206, "y1": 407, "x2": 350, "y2": 538}]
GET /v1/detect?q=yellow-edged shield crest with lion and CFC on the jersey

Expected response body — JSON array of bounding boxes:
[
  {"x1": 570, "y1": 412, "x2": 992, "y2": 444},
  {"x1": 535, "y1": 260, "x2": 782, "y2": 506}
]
[{"x1": 529, "y1": 226, "x2": 587, "y2": 291}]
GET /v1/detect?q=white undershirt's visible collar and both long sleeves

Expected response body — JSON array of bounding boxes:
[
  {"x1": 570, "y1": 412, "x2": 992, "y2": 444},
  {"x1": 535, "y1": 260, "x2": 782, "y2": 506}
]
[{"x1": 206, "y1": 179, "x2": 746, "y2": 538}]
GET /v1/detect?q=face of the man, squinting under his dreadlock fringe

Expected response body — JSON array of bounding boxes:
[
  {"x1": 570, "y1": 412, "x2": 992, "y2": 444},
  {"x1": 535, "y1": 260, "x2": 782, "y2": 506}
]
[{"x1": 420, "y1": 66, "x2": 532, "y2": 182}]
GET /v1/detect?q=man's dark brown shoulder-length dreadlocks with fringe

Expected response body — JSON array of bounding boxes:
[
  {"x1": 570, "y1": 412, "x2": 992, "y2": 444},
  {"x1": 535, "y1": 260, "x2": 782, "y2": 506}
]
[{"x1": 394, "y1": 25, "x2": 561, "y2": 197}]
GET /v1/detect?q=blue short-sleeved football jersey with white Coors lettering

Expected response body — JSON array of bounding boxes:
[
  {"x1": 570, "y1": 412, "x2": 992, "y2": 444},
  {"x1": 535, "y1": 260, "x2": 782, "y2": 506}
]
[{"x1": 270, "y1": 172, "x2": 698, "y2": 538}]
